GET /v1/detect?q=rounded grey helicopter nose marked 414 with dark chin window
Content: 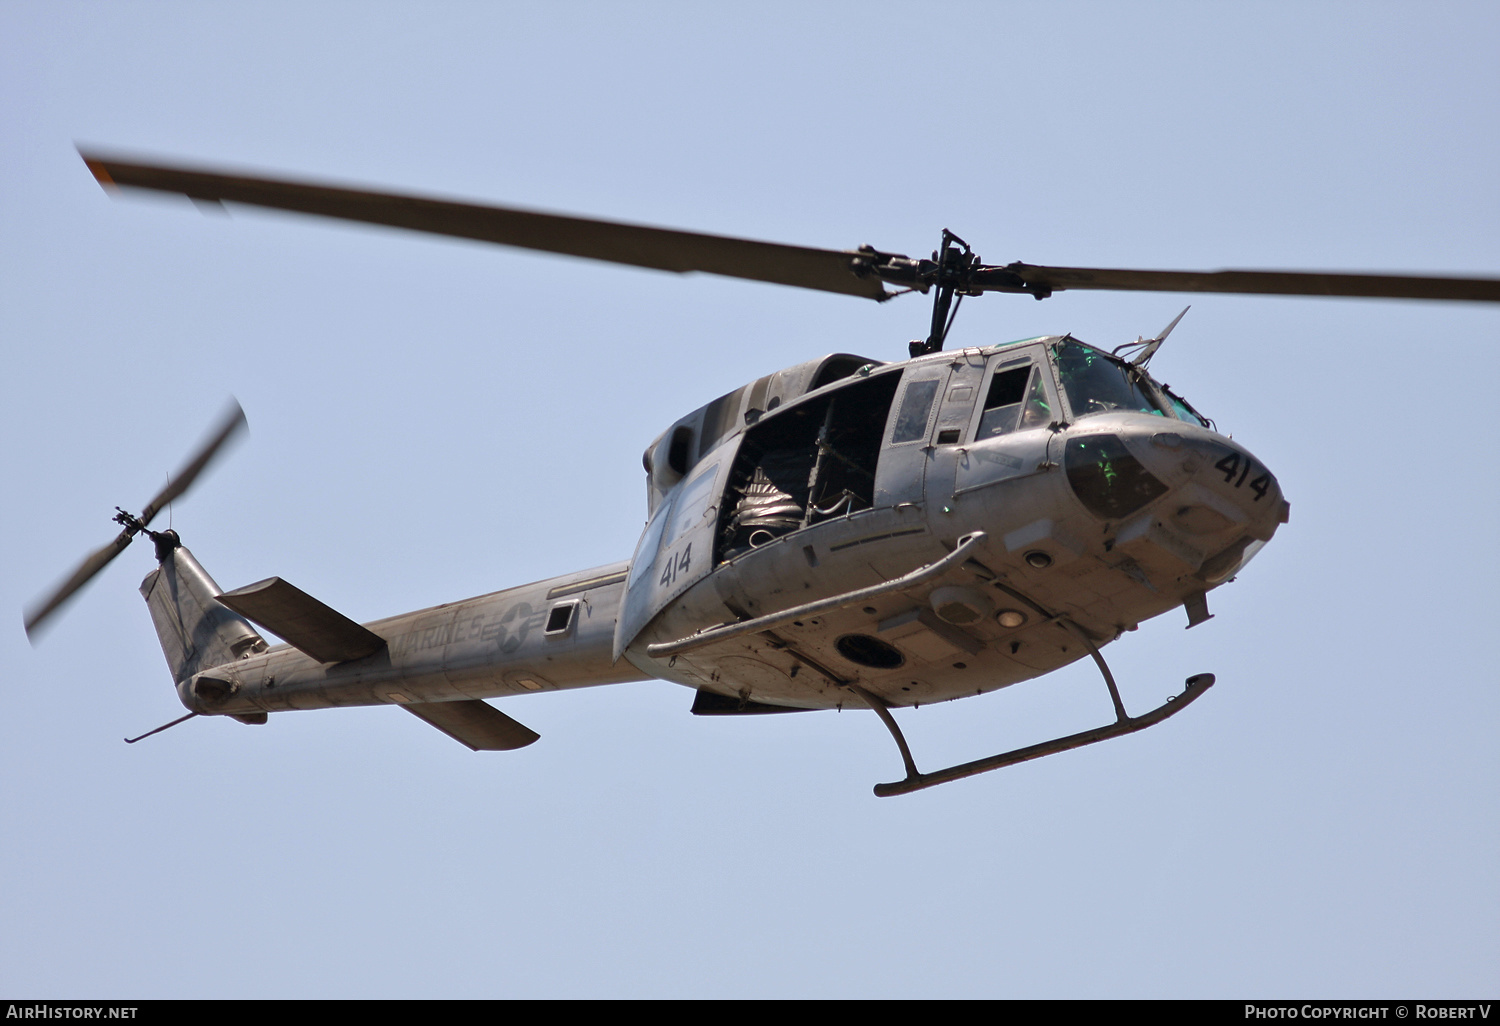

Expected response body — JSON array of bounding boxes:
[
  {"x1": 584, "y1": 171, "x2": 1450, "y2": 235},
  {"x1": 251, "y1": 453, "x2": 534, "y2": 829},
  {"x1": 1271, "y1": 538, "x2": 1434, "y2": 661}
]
[{"x1": 1064, "y1": 416, "x2": 1290, "y2": 585}]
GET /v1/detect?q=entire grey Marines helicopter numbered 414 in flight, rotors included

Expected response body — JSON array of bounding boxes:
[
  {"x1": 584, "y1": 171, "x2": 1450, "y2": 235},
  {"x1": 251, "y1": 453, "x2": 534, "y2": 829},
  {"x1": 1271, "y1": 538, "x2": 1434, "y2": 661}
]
[{"x1": 26, "y1": 153, "x2": 1500, "y2": 797}]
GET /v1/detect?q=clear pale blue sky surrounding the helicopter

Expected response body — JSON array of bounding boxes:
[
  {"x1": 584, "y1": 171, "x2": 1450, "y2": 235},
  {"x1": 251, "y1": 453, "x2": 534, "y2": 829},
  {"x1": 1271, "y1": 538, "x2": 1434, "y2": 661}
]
[{"x1": 0, "y1": 3, "x2": 1500, "y2": 998}]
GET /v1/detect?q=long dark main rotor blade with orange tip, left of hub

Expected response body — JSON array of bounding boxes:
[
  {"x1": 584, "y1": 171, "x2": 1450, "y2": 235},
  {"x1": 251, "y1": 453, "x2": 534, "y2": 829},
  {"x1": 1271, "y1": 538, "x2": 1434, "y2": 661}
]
[{"x1": 80, "y1": 153, "x2": 888, "y2": 300}]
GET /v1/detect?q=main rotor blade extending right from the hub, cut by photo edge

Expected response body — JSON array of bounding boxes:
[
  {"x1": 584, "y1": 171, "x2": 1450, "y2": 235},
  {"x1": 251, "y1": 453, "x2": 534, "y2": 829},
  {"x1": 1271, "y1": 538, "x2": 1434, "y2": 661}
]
[{"x1": 980, "y1": 264, "x2": 1500, "y2": 303}]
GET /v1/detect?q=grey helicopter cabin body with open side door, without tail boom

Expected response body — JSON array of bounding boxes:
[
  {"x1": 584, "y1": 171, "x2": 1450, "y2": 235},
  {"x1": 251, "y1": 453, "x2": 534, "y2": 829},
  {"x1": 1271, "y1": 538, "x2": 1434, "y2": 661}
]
[{"x1": 615, "y1": 336, "x2": 1287, "y2": 708}]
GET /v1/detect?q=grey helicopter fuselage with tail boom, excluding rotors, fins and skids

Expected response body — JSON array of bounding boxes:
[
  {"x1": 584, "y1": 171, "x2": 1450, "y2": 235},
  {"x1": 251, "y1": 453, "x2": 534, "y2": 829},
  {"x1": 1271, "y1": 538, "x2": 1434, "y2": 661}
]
[{"x1": 170, "y1": 336, "x2": 1287, "y2": 716}]
